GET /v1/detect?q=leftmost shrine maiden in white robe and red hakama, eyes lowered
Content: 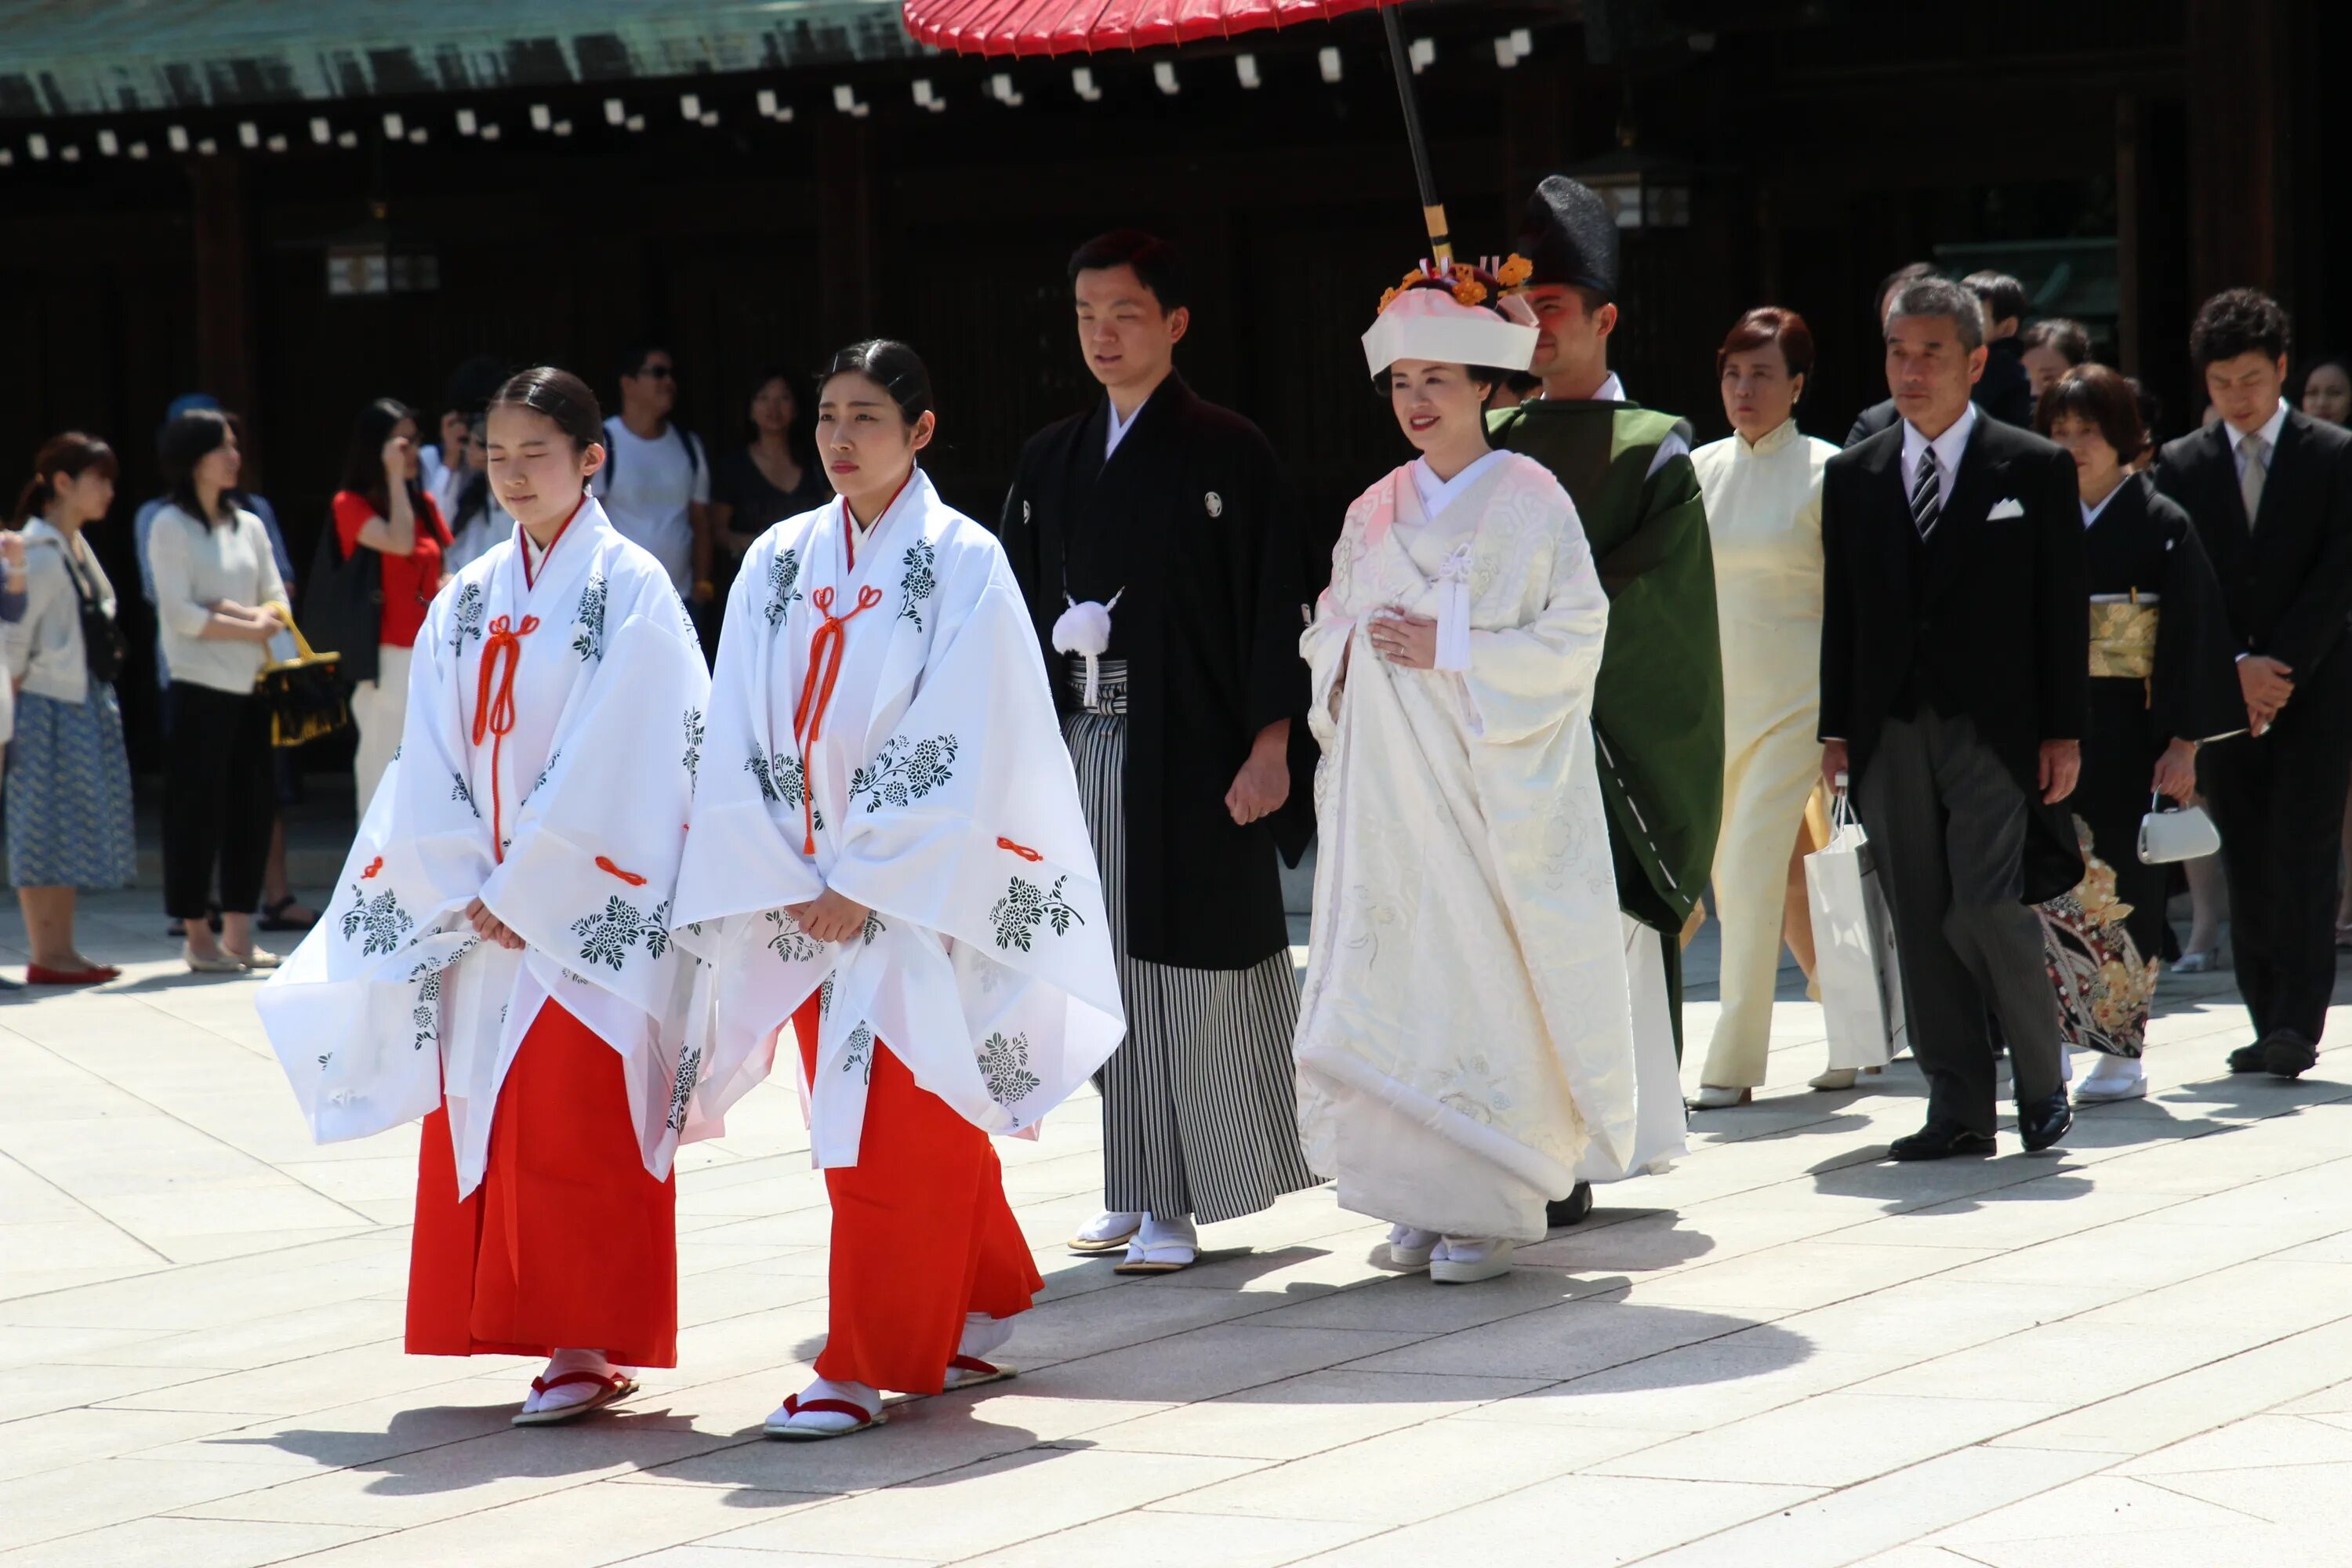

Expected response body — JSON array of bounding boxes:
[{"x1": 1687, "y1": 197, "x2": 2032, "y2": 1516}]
[{"x1": 259, "y1": 369, "x2": 710, "y2": 1425}]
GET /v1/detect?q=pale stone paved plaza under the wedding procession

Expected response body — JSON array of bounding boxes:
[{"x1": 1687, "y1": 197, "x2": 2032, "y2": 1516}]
[{"x1": 0, "y1": 893, "x2": 2352, "y2": 1568}]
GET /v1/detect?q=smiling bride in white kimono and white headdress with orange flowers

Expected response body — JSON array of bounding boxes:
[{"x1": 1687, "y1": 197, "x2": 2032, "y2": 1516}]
[{"x1": 1296, "y1": 259, "x2": 1635, "y2": 1283}]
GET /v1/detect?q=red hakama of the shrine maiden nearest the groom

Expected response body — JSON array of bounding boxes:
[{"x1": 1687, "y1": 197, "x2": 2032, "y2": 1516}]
[{"x1": 793, "y1": 996, "x2": 1044, "y2": 1394}]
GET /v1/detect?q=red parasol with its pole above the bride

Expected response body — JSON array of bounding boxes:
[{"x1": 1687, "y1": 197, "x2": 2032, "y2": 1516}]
[{"x1": 901, "y1": 0, "x2": 1454, "y2": 266}]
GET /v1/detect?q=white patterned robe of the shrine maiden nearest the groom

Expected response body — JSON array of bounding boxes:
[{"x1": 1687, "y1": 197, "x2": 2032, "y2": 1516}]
[{"x1": 673, "y1": 470, "x2": 1127, "y2": 1166}]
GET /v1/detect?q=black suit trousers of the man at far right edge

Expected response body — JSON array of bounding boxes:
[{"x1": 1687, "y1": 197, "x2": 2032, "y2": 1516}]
[{"x1": 2197, "y1": 681, "x2": 2352, "y2": 1046}]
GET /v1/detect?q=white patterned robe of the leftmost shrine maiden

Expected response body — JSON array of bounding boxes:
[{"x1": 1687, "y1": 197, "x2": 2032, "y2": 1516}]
[{"x1": 259, "y1": 499, "x2": 710, "y2": 1196}]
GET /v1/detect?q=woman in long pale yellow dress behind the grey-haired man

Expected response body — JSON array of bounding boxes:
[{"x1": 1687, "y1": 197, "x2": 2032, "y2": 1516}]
[{"x1": 1691, "y1": 306, "x2": 1837, "y2": 1109}]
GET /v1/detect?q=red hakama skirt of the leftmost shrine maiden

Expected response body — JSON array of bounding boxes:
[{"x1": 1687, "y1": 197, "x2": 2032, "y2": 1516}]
[{"x1": 407, "y1": 1001, "x2": 677, "y2": 1366}]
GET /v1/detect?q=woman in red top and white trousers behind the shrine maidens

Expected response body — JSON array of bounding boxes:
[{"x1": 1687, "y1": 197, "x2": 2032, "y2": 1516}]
[{"x1": 334, "y1": 397, "x2": 449, "y2": 815}]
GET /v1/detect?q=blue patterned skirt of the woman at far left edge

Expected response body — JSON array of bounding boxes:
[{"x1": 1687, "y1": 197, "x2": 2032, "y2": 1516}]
[{"x1": 7, "y1": 682, "x2": 139, "y2": 891}]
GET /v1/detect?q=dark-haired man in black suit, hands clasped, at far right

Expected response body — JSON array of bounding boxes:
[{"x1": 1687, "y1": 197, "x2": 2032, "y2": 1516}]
[{"x1": 2157, "y1": 289, "x2": 2352, "y2": 1079}]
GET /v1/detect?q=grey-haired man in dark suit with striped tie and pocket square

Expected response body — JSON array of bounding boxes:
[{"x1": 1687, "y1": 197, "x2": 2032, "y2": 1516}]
[{"x1": 1820, "y1": 278, "x2": 2089, "y2": 1159}]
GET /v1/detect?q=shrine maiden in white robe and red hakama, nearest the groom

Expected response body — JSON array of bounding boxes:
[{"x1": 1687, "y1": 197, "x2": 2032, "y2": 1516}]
[{"x1": 675, "y1": 341, "x2": 1127, "y2": 1439}]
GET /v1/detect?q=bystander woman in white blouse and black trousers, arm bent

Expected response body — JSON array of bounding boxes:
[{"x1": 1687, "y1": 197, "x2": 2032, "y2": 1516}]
[{"x1": 148, "y1": 409, "x2": 292, "y2": 973}]
